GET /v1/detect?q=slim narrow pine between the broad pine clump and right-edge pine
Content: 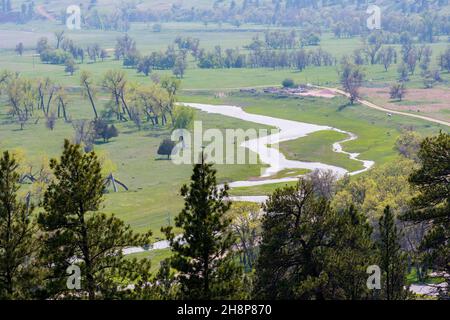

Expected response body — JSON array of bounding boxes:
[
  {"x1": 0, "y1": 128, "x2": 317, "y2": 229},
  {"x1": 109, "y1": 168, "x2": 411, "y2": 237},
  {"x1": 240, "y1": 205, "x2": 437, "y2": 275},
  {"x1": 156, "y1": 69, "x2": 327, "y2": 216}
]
[{"x1": 378, "y1": 206, "x2": 407, "y2": 300}]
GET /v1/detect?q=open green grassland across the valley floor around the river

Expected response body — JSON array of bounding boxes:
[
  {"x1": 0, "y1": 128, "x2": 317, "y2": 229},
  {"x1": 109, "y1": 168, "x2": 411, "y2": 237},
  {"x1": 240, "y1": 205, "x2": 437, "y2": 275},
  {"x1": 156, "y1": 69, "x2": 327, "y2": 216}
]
[{"x1": 0, "y1": 18, "x2": 450, "y2": 238}]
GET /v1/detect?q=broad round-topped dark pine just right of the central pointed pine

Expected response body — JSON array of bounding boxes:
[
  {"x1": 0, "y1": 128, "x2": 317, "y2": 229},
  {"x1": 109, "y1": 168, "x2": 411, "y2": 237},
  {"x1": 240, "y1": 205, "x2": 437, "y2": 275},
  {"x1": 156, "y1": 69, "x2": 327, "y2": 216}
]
[{"x1": 254, "y1": 179, "x2": 332, "y2": 299}]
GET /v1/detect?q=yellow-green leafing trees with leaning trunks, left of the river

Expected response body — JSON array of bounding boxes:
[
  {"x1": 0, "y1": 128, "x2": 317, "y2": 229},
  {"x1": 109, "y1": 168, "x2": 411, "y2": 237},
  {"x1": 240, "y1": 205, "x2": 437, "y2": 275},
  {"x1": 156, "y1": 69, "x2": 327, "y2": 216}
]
[{"x1": 0, "y1": 70, "x2": 181, "y2": 135}]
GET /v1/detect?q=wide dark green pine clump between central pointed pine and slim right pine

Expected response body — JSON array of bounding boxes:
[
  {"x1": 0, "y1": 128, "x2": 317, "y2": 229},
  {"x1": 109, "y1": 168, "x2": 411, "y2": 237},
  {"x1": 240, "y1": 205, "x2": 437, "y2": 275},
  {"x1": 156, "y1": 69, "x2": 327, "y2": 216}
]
[{"x1": 254, "y1": 179, "x2": 374, "y2": 299}]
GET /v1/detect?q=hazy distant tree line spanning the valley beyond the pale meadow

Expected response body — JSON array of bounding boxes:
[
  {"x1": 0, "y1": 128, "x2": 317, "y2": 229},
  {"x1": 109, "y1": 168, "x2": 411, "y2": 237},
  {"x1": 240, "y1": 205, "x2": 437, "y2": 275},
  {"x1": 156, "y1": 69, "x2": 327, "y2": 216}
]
[{"x1": 29, "y1": 31, "x2": 450, "y2": 82}]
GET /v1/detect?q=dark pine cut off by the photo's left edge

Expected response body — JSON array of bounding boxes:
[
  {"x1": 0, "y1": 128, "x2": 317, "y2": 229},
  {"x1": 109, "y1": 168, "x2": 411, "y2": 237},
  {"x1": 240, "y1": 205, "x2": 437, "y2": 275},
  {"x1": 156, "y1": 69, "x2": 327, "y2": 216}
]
[{"x1": 0, "y1": 152, "x2": 36, "y2": 299}]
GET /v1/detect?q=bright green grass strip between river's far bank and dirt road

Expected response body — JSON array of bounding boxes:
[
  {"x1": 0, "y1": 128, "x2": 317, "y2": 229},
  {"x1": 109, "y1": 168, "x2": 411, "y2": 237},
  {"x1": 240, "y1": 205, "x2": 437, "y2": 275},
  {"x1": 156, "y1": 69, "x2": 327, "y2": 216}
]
[{"x1": 182, "y1": 93, "x2": 449, "y2": 165}]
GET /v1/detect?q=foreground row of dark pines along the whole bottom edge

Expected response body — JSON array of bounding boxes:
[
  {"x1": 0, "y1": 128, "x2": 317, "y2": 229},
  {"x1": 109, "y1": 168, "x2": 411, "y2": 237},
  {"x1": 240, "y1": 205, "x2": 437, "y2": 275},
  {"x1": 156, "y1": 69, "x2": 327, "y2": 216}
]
[{"x1": 0, "y1": 133, "x2": 450, "y2": 300}]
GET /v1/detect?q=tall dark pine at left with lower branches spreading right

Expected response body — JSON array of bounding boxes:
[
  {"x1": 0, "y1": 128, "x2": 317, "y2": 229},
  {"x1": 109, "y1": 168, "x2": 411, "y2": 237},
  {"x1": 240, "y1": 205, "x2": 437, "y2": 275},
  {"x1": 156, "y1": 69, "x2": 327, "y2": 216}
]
[{"x1": 38, "y1": 140, "x2": 150, "y2": 300}]
